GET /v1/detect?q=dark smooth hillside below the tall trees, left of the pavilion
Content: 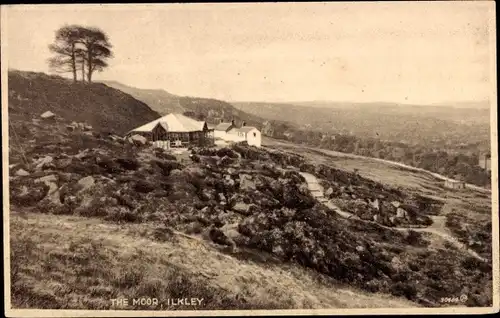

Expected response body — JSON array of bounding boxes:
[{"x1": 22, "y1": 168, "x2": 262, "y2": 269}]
[{"x1": 9, "y1": 71, "x2": 159, "y2": 134}]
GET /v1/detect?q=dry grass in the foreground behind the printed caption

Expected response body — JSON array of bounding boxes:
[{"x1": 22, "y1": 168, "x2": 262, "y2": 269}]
[{"x1": 10, "y1": 213, "x2": 417, "y2": 310}]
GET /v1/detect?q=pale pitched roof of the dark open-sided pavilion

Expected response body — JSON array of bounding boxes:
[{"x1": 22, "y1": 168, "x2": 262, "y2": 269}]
[{"x1": 130, "y1": 113, "x2": 205, "y2": 132}]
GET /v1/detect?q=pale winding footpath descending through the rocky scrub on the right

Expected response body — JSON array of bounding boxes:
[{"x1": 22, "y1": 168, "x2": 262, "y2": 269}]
[{"x1": 299, "y1": 172, "x2": 486, "y2": 261}]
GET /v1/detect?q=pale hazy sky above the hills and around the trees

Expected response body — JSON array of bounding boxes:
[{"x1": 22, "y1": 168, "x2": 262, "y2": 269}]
[{"x1": 2, "y1": 2, "x2": 495, "y2": 103}]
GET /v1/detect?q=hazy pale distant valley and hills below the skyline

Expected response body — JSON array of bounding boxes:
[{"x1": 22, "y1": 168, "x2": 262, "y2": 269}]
[{"x1": 232, "y1": 102, "x2": 490, "y2": 145}]
